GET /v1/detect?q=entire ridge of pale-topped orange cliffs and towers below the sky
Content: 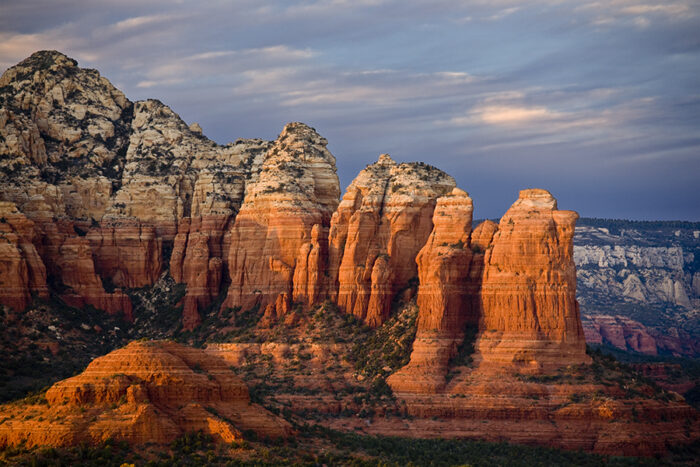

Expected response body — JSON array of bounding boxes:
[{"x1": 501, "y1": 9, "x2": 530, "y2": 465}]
[{"x1": 0, "y1": 52, "x2": 672, "y2": 372}]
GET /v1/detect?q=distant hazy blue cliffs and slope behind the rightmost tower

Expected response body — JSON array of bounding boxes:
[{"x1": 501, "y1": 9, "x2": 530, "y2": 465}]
[{"x1": 574, "y1": 223, "x2": 700, "y2": 357}]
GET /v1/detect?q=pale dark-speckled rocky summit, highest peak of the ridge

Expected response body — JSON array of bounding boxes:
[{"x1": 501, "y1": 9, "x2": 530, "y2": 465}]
[{"x1": 0, "y1": 51, "x2": 133, "y2": 199}]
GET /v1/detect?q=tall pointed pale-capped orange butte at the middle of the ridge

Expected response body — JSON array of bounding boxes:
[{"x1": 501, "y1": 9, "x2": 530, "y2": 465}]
[{"x1": 224, "y1": 123, "x2": 340, "y2": 319}]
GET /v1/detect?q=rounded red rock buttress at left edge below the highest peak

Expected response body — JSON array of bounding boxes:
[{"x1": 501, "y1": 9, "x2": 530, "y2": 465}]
[{"x1": 0, "y1": 202, "x2": 48, "y2": 311}]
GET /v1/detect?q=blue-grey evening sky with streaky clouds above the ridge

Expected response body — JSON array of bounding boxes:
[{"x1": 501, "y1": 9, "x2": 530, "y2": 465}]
[{"x1": 0, "y1": 0, "x2": 700, "y2": 221}]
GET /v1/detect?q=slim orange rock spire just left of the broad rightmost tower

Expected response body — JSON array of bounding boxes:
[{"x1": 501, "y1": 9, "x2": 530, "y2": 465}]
[{"x1": 389, "y1": 188, "x2": 478, "y2": 393}]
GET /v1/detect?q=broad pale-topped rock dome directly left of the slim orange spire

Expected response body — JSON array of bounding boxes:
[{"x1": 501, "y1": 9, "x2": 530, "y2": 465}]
[{"x1": 328, "y1": 154, "x2": 455, "y2": 327}]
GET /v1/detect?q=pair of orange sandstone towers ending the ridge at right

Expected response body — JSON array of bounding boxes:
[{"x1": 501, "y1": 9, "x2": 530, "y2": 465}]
[{"x1": 388, "y1": 189, "x2": 590, "y2": 394}]
